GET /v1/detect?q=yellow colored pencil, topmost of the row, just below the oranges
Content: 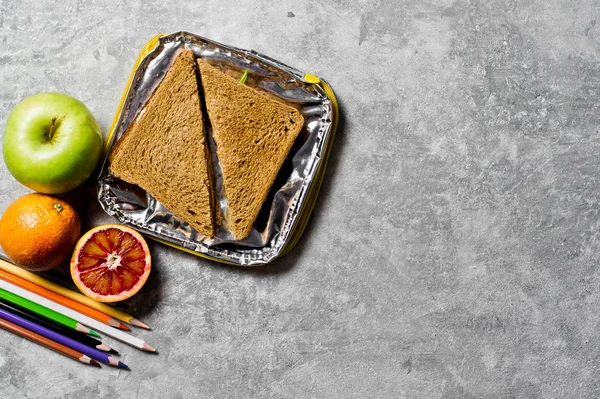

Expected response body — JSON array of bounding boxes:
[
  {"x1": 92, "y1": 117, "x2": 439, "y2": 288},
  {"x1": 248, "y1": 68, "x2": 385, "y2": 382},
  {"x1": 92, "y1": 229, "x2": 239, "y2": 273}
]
[{"x1": 0, "y1": 255, "x2": 150, "y2": 329}]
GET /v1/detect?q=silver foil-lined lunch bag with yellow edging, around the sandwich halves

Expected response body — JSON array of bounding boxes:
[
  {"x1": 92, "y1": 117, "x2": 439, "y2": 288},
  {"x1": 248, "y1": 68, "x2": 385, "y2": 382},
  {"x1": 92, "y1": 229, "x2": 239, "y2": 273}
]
[{"x1": 98, "y1": 32, "x2": 333, "y2": 266}]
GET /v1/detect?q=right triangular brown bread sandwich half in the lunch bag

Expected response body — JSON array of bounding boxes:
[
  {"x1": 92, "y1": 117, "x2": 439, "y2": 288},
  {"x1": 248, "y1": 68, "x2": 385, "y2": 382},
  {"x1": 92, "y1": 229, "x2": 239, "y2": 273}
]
[{"x1": 197, "y1": 59, "x2": 304, "y2": 240}]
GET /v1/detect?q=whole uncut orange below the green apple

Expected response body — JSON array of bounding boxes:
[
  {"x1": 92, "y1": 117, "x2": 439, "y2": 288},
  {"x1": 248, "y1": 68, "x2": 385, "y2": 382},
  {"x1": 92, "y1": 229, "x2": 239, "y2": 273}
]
[{"x1": 0, "y1": 194, "x2": 81, "y2": 271}]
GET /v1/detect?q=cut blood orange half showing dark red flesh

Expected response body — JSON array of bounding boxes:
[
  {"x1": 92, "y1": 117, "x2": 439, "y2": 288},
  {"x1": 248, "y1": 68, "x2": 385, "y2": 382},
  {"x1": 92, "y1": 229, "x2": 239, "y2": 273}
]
[{"x1": 71, "y1": 224, "x2": 151, "y2": 302}]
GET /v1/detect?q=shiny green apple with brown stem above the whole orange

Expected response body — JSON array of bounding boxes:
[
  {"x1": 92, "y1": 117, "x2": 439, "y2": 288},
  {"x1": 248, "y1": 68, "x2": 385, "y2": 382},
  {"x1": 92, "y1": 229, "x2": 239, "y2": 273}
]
[{"x1": 4, "y1": 93, "x2": 102, "y2": 194}]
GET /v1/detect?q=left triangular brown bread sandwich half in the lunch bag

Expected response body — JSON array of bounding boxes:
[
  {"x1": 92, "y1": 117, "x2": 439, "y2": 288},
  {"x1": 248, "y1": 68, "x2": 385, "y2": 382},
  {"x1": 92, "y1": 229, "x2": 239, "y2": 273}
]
[{"x1": 109, "y1": 51, "x2": 219, "y2": 238}]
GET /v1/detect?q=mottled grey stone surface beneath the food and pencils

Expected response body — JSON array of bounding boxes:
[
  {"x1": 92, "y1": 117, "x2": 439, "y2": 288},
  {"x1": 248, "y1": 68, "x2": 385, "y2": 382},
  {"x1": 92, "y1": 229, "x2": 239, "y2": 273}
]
[{"x1": 0, "y1": 0, "x2": 600, "y2": 398}]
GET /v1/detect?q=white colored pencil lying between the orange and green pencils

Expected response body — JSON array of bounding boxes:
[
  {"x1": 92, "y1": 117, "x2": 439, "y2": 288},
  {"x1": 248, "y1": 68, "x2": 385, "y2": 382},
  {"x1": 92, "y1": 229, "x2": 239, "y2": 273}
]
[{"x1": 0, "y1": 280, "x2": 156, "y2": 352}]
